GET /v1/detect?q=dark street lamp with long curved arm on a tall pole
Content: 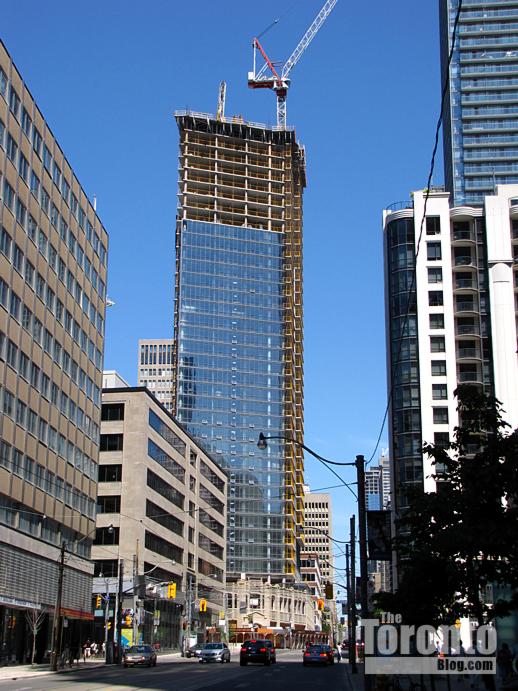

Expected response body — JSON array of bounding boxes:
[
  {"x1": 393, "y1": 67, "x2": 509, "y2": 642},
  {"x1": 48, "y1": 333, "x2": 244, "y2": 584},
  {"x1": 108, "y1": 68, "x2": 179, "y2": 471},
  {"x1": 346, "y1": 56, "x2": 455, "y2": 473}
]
[{"x1": 257, "y1": 432, "x2": 369, "y2": 686}]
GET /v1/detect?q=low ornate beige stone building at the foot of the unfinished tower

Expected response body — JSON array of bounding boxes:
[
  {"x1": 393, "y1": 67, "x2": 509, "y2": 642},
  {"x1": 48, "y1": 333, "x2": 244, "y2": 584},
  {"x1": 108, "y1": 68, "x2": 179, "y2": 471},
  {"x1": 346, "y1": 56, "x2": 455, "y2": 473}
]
[{"x1": 226, "y1": 577, "x2": 322, "y2": 642}]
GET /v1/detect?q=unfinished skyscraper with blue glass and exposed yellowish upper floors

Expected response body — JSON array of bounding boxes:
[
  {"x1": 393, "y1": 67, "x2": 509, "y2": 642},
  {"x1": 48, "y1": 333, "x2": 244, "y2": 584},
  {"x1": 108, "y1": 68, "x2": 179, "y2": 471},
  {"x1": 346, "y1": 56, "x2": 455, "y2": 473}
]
[{"x1": 173, "y1": 112, "x2": 305, "y2": 579}]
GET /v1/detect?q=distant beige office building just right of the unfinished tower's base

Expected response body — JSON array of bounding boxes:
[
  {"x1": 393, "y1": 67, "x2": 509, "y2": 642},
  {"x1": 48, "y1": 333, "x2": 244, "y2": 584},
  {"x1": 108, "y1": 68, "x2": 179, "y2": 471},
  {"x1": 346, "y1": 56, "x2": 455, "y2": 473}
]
[{"x1": 304, "y1": 486, "x2": 335, "y2": 584}]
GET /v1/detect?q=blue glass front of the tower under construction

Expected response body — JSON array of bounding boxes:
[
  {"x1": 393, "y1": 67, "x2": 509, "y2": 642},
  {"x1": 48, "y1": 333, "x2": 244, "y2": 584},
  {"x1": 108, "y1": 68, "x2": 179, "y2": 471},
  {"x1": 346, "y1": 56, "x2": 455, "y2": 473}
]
[{"x1": 176, "y1": 220, "x2": 285, "y2": 574}]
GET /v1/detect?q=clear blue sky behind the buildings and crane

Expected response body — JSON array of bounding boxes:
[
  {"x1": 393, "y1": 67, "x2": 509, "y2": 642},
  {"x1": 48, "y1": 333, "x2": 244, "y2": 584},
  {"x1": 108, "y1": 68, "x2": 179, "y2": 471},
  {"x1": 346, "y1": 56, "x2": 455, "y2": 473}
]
[{"x1": 0, "y1": 0, "x2": 443, "y2": 572}]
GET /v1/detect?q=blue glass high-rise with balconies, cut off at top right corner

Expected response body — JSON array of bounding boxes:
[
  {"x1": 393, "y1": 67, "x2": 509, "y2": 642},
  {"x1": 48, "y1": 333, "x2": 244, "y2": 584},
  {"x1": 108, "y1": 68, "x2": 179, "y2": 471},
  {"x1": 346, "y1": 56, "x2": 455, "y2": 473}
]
[{"x1": 440, "y1": 0, "x2": 518, "y2": 206}]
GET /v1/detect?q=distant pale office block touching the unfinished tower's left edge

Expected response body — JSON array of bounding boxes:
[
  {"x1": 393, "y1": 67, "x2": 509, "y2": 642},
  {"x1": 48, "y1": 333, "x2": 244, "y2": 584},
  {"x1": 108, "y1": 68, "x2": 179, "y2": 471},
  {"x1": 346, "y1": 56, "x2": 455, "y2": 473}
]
[{"x1": 137, "y1": 338, "x2": 174, "y2": 413}]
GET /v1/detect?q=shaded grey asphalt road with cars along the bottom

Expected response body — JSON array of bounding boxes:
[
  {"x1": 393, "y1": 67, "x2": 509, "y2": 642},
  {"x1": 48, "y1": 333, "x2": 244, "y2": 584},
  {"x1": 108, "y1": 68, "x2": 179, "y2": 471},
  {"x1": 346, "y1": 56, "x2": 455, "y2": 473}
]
[{"x1": 0, "y1": 651, "x2": 348, "y2": 691}]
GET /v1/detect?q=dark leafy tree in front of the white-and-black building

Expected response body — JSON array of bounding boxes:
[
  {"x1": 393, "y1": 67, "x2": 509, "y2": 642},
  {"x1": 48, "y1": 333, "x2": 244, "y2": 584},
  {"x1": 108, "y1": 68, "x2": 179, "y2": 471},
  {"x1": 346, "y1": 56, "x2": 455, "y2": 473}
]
[{"x1": 378, "y1": 385, "x2": 518, "y2": 625}]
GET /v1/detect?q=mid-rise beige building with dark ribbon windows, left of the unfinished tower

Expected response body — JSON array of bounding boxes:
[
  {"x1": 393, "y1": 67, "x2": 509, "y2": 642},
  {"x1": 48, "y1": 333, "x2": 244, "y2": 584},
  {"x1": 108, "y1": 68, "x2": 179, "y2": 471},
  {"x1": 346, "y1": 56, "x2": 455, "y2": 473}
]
[{"x1": 92, "y1": 378, "x2": 227, "y2": 648}]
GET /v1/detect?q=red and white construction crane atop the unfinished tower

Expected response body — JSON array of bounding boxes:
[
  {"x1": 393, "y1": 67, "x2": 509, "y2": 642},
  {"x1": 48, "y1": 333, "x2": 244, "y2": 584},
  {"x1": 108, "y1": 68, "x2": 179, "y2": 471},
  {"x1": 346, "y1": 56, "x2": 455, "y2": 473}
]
[{"x1": 248, "y1": 0, "x2": 338, "y2": 128}]
